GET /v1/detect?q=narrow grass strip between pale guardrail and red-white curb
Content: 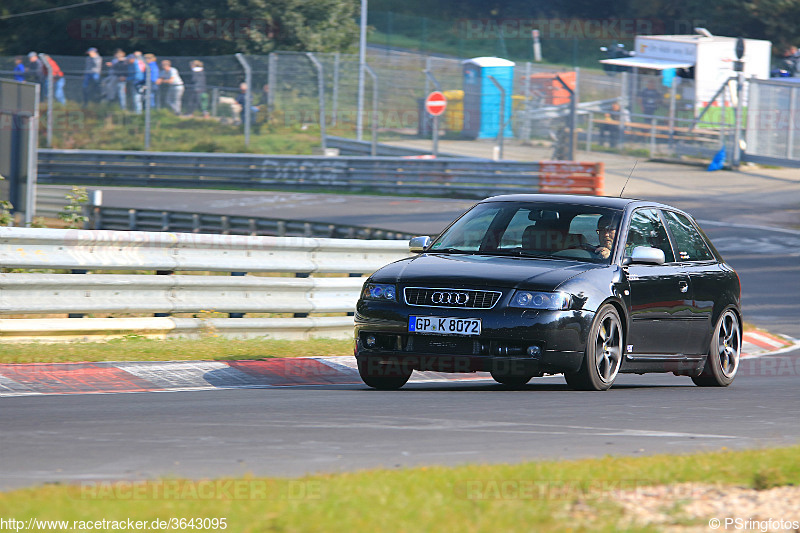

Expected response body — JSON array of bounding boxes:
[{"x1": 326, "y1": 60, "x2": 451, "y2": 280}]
[{"x1": 0, "y1": 336, "x2": 353, "y2": 363}]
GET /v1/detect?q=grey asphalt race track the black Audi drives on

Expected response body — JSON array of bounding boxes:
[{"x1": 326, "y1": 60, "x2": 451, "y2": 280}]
[{"x1": 0, "y1": 167, "x2": 800, "y2": 490}]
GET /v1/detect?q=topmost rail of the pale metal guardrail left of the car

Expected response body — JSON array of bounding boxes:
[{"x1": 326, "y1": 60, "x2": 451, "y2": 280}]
[{"x1": 0, "y1": 227, "x2": 409, "y2": 272}]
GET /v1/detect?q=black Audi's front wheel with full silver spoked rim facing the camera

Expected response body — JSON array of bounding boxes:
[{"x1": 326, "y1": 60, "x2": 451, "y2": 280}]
[{"x1": 564, "y1": 304, "x2": 624, "y2": 391}]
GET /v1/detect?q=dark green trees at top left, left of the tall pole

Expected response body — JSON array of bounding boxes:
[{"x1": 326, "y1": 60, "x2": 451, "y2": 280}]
[{"x1": 0, "y1": 0, "x2": 358, "y2": 56}]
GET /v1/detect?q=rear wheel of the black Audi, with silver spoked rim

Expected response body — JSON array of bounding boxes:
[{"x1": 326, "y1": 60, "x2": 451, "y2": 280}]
[{"x1": 692, "y1": 309, "x2": 742, "y2": 387}]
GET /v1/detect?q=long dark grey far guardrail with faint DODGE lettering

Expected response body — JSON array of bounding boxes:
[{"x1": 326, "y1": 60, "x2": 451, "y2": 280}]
[{"x1": 39, "y1": 150, "x2": 602, "y2": 198}]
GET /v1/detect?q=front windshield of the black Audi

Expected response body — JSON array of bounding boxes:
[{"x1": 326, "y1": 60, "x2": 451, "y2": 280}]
[{"x1": 428, "y1": 202, "x2": 622, "y2": 264}]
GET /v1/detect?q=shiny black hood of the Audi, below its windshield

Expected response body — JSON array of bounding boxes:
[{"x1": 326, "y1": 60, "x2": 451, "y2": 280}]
[{"x1": 372, "y1": 254, "x2": 605, "y2": 290}]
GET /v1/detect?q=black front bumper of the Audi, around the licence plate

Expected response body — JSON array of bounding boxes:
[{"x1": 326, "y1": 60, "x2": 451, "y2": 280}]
[{"x1": 355, "y1": 300, "x2": 594, "y2": 375}]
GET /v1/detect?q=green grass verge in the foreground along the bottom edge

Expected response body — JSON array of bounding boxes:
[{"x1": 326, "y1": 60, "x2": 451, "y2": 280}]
[{"x1": 0, "y1": 446, "x2": 800, "y2": 533}]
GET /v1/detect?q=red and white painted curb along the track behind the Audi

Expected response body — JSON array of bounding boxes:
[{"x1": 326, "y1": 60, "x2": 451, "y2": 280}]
[{"x1": 0, "y1": 331, "x2": 800, "y2": 397}]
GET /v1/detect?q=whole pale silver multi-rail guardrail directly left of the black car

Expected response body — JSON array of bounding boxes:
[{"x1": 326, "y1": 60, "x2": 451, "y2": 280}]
[{"x1": 0, "y1": 227, "x2": 410, "y2": 339}]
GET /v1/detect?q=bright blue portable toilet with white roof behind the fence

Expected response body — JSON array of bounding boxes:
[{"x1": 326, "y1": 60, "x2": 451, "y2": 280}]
[{"x1": 462, "y1": 57, "x2": 514, "y2": 139}]
